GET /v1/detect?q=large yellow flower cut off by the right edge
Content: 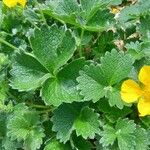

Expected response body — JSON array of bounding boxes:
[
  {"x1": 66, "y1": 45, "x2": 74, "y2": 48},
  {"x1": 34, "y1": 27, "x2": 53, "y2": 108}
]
[{"x1": 121, "y1": 66, "x2": 150, "y2": 116}]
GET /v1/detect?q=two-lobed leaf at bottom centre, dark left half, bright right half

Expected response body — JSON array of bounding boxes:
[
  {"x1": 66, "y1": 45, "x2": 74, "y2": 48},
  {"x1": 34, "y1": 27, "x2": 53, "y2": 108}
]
[{"x1": 52, "y1": 103, "x2": 99, "y2": 143}]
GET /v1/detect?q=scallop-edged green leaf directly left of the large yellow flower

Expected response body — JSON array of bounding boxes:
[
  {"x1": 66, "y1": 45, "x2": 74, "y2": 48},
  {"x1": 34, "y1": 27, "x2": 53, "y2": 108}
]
[{"x1": 77, "y1": 50, "x2": 133, "y2": 103}]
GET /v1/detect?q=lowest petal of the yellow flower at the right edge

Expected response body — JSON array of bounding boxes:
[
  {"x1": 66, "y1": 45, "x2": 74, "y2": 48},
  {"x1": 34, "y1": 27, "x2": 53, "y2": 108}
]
[{"x1": 138, "y1": 98, "x2": 150, "y2": 116}]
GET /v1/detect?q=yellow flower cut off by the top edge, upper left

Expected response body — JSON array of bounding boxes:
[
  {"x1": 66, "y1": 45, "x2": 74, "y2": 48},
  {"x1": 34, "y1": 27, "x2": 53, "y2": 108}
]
[{"x1": 3, "y1": 0, "x2": 27, "y2": 8}]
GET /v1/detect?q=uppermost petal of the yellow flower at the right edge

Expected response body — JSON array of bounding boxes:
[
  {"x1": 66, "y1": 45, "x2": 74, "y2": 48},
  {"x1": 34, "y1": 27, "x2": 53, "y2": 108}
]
[{"x1": 139, "y1": 66, "x2": 150, "y2": 85}]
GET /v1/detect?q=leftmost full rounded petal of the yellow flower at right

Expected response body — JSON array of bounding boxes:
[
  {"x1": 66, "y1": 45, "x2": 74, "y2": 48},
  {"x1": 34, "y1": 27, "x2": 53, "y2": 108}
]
[{"x1": 121, "y1": 80, "x2": 142, "y2": 103}]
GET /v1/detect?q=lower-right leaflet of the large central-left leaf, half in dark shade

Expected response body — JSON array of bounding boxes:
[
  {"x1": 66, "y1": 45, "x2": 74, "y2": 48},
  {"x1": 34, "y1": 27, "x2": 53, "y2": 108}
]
[{"x1": 41, "y1": 59, "x2": 85, "y2": 106}]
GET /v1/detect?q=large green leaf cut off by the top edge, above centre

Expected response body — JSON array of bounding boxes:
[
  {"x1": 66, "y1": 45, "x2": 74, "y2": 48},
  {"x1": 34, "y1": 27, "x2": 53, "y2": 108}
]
[{"x1": 43, "y1": 0, "x2": 114, "y2": 32}]
